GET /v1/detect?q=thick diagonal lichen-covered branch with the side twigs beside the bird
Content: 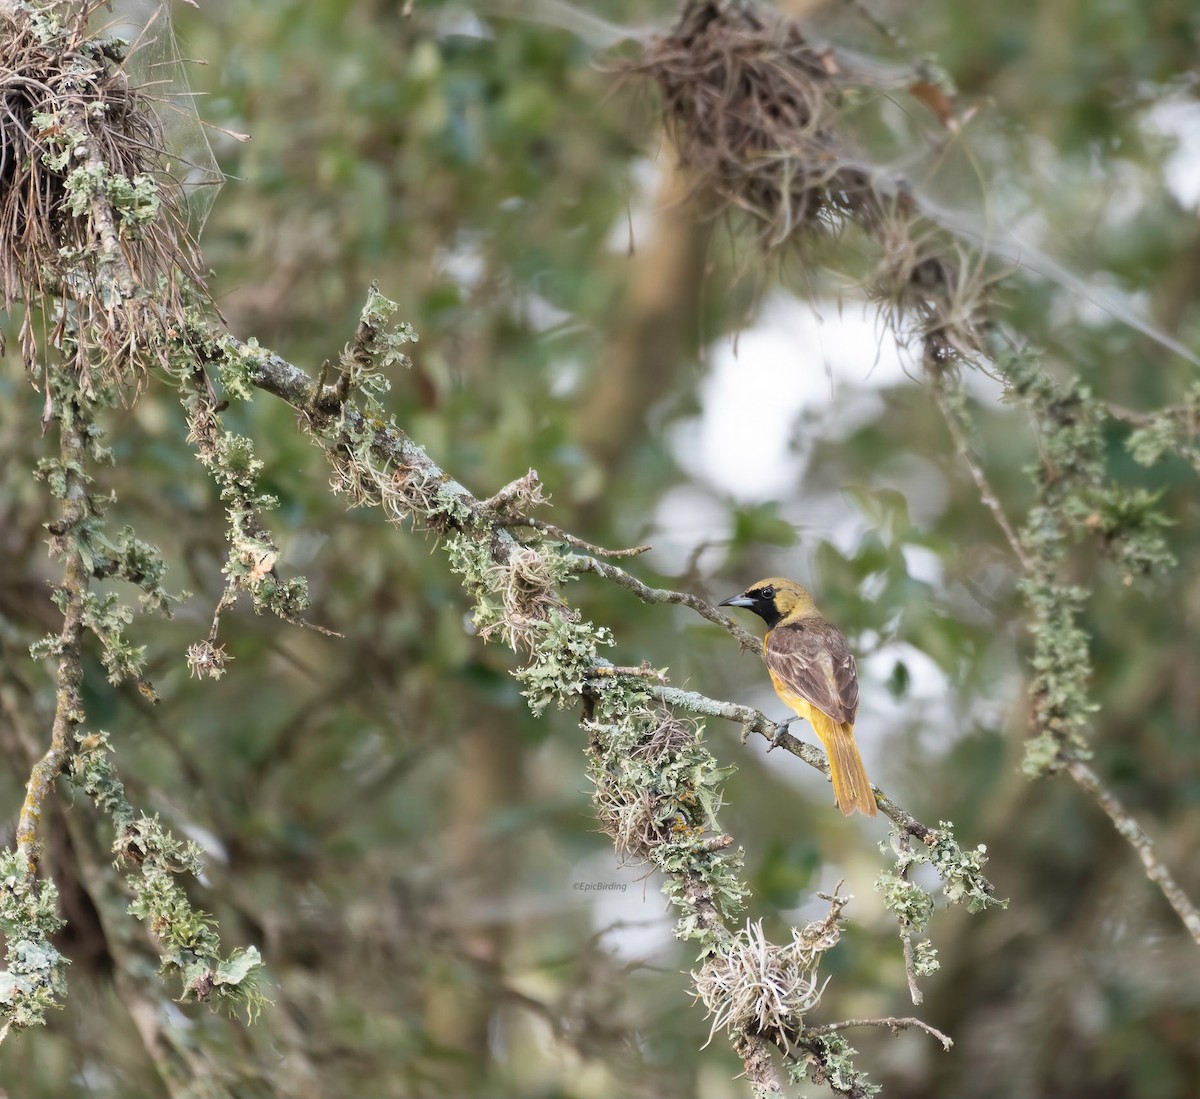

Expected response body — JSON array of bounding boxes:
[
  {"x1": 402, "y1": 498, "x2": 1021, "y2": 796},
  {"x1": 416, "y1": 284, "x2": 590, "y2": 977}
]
[{"x1": 196, "y1": 290, "x2": 995, "y2": 1094}]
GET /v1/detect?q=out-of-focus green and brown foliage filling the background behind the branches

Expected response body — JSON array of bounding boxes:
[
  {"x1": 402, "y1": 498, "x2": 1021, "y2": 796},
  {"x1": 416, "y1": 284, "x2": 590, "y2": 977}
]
[{"x1": 0, "y1": 0, "x2": 1200, "y2": 1099}]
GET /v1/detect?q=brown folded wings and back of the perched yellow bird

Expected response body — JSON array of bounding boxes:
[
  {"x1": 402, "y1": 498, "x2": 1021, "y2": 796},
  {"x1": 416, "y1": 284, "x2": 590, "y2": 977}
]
[{"x1": 763, "y1": 618, "x2": 858, "y2": 725}]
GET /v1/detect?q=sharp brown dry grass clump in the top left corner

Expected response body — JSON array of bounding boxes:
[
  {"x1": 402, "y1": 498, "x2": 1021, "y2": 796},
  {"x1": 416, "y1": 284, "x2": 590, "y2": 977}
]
[{"x1": 0, "y1": 0, "x2": 202, "y2": 383}]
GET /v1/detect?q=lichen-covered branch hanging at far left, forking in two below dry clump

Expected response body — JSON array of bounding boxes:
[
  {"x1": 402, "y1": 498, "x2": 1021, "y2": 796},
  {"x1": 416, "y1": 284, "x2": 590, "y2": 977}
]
[{"x1": 0, "y1": 347, "x2": 263, "y2": 1027}]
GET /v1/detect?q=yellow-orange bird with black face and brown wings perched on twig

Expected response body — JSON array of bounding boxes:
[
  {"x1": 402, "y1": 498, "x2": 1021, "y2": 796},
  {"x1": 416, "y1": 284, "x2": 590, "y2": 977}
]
[{"x1": 720, "y1": 577, "x2": 878, "y2": 817}]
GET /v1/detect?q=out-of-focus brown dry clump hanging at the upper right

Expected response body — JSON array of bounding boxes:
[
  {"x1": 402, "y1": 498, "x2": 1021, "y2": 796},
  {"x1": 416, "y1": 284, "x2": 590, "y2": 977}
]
[{"x1": 623, "y1": 0, "x2": 991, "y2": 368}]
